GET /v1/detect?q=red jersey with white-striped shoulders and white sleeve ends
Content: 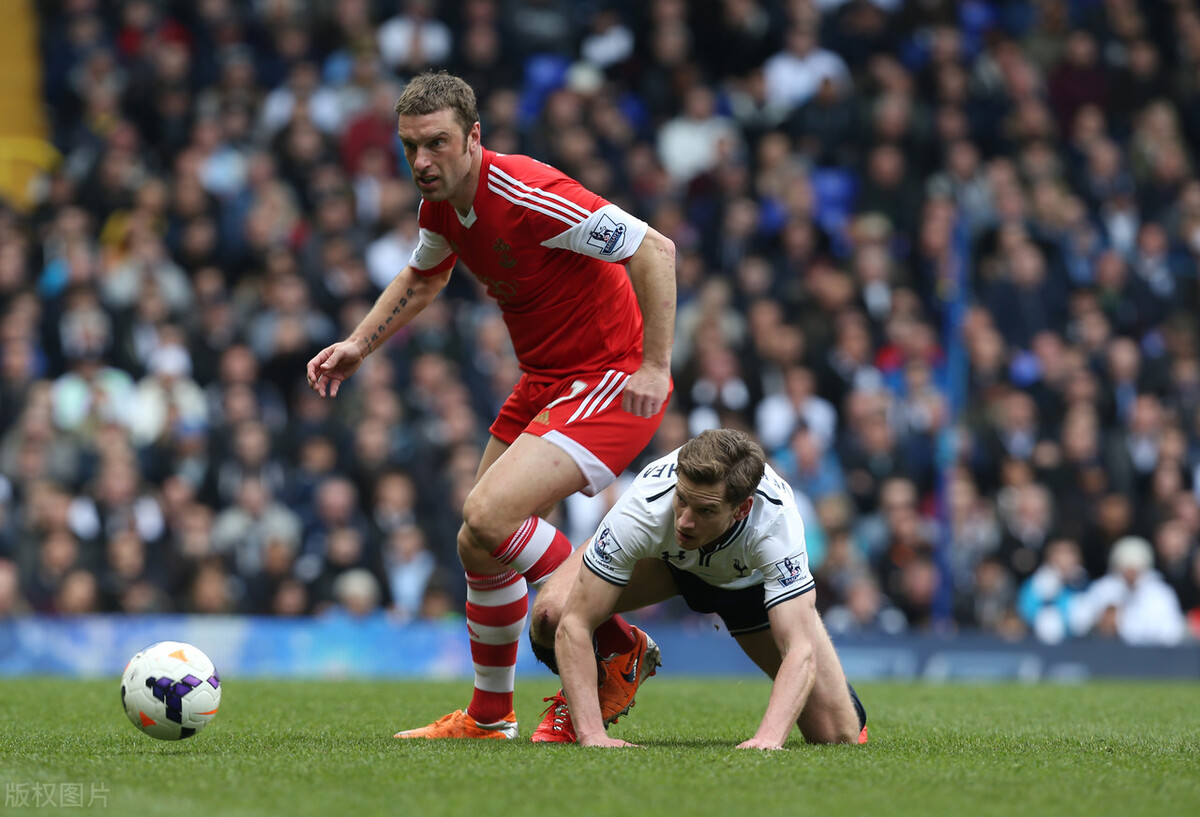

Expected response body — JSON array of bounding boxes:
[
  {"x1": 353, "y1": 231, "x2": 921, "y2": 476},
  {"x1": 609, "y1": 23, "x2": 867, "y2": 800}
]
[{"x1": 409, "y1": 150, "x2": 647, "y2": 378}]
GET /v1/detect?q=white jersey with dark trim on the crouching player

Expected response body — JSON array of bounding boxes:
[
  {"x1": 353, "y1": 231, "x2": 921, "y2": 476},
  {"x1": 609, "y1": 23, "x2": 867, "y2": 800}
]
[{"x1": 583, "y1": 449, "x2": 815, "y2": 609}]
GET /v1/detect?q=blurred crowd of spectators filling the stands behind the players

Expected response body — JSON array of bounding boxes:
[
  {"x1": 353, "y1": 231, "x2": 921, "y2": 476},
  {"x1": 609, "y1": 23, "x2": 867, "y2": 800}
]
[{"x1": 0, "y1": 0, "x2": 1200, "y2": 644}]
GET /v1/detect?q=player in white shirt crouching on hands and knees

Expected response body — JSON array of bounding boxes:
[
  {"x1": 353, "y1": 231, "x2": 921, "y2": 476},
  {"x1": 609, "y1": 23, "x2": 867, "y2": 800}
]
[{"x1": 530, "y1": 429, "x2": 866, "y2": 749}]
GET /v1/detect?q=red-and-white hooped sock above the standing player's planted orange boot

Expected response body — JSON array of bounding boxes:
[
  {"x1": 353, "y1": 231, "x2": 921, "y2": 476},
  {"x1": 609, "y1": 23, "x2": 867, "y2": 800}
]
[{"x1": 467, "y1": 570, "x2": 529, "y2": 723}]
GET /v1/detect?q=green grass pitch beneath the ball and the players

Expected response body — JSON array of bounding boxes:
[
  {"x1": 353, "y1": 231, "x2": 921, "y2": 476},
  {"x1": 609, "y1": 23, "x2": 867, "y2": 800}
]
[{"x1": 0, "y1": 675, "x2": 1200, "y2": 817}]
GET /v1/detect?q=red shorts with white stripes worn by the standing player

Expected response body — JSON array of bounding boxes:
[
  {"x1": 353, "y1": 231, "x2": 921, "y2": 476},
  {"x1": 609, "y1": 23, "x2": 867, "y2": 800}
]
[{"x1": 490, "y1": 370, "x2": 670, "y2": 497}]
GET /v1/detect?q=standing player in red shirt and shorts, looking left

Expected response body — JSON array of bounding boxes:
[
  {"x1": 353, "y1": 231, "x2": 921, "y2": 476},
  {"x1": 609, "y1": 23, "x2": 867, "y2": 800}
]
[{"x1": 307, "y1": 73, "x2": 676, "y2": 738}]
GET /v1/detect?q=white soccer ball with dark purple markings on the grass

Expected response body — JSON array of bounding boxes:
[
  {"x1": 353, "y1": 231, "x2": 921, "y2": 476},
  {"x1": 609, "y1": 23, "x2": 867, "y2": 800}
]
[{"x1": 121, "y1": 641, "x2": 221, "y2": 740}]
